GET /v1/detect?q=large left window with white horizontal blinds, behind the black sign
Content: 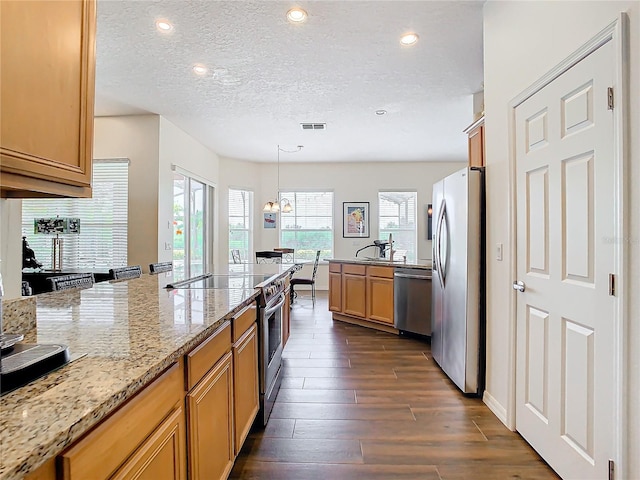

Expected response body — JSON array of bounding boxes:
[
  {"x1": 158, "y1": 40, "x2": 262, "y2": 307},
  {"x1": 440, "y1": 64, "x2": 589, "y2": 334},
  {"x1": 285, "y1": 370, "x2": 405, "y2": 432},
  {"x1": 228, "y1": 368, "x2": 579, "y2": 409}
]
[{"x1": 22, "y1": 159, "x2": 129, "y2": 270}]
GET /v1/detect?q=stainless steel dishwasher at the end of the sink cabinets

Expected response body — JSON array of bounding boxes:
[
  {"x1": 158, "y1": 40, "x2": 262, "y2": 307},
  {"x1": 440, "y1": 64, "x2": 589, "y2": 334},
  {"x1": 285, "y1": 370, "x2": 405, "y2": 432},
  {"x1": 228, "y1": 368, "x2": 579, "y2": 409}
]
[{"x1": 393, "y1": 268, "x2": 431, "y2": 336}]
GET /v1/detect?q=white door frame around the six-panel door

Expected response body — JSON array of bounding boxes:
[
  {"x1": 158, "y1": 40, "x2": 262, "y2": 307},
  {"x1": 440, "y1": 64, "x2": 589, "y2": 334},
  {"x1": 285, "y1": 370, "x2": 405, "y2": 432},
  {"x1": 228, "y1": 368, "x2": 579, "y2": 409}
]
[{"x1": 506, "y1": 13, "x2": 631, "y2": 478}]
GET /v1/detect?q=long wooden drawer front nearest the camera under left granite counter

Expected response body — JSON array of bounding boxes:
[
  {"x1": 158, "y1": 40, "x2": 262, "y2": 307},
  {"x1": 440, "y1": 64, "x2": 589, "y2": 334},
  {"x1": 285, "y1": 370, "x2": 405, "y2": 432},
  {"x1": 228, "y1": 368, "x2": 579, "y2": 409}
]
[{"x1": 59, "y1": 363, "x2": 184, "y2": 480}]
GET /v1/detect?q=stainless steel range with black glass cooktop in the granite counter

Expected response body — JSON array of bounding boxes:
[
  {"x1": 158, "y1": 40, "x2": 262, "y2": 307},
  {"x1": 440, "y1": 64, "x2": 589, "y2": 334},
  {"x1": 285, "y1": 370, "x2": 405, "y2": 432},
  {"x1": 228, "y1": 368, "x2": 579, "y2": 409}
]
[{"x1": 167, "y1": 272, "x2": 285, "y2": 426}]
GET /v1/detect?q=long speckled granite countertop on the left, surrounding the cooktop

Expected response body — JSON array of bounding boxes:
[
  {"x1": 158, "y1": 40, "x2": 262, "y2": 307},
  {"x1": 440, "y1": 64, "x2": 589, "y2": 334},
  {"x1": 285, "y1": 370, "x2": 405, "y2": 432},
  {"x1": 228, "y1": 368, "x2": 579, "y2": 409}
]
[{"x1": 0, "y1": 265, "x2": 293, "y2": 480}]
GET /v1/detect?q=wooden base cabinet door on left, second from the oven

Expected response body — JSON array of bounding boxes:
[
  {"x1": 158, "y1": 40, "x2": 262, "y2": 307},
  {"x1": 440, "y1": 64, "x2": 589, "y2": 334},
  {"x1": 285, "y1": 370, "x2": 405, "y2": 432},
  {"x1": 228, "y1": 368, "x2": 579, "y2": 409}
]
[{"x1": 187, "y1": 352, "x2": 235, "y2": 480}]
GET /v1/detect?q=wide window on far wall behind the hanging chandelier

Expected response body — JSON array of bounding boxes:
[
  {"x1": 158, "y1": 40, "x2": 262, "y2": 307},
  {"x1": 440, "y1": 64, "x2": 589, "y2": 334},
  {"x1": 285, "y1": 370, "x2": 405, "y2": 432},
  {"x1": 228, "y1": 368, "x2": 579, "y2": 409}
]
[{"x1": 280, "y1": 192, "x2": 333, "y2": 260}]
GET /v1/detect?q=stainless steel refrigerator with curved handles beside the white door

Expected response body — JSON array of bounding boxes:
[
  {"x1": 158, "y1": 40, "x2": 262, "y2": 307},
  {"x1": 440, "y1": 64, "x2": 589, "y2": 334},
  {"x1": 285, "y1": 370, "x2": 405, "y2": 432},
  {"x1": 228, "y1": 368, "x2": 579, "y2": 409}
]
[{"x1": 431, "y1": 167, "x2": 485, "y2": 395}]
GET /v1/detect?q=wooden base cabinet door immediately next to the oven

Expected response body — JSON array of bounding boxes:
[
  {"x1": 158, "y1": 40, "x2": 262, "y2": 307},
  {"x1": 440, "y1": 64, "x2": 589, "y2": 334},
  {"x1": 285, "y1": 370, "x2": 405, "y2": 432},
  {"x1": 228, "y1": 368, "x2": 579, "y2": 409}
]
[{"x1": 233, "y1": 322, "x2": 260, "y2": 455}]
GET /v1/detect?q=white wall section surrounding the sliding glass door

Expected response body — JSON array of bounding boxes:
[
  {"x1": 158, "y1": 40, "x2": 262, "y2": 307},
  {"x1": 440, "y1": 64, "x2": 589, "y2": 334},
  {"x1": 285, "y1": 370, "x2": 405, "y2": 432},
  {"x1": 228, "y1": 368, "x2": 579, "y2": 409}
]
[{"x1": 156, "y1": 117, "x2": 221, "y2": 264}]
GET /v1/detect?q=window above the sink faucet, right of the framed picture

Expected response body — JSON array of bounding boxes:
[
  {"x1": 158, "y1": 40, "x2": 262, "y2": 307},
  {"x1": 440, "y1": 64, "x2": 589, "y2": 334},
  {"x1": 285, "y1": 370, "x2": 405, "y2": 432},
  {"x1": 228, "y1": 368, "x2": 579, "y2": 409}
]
[{"x1": 378, "y1": 192, "x2": 418, "y2": 262}]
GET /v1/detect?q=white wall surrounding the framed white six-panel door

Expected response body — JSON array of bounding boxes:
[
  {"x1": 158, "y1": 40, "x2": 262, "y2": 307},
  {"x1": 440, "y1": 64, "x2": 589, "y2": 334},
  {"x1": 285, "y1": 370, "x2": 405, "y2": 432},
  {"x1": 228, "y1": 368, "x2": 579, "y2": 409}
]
[{"x1": 484, "y1": 1, "x2": 640, "y2": 478}]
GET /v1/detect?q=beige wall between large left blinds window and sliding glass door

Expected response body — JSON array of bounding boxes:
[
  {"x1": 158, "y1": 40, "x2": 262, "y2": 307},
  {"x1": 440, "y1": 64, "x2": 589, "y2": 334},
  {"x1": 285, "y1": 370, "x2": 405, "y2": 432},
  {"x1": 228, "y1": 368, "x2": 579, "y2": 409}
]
[{"x1": 93, "y1": 115, "x2": 160, "y2": 271}]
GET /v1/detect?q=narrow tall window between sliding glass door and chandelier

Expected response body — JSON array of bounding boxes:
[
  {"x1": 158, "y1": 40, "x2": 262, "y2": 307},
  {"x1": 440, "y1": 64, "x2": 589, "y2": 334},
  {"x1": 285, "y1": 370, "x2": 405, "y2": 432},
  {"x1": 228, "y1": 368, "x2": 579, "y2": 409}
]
[{"x1": 229, "y1": 188, "x2": 253, "y2": 263}]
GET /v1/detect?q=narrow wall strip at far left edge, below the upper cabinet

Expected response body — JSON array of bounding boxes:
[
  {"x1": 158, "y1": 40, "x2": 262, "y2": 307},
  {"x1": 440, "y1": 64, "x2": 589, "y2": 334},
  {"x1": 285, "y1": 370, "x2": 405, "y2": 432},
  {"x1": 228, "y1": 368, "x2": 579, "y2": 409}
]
[{"x1": 0, "y1": 199, "x2": 22, "y2": 298}]
